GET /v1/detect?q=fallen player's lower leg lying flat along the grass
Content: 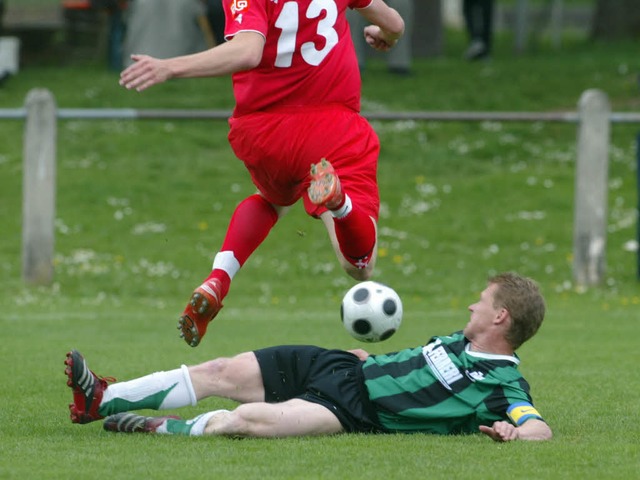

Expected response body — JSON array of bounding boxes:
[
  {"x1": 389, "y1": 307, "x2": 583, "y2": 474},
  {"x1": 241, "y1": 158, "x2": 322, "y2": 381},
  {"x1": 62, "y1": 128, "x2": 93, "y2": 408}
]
[{"x1": 104, "y1": 398, "x2": 344, "y2": 437}]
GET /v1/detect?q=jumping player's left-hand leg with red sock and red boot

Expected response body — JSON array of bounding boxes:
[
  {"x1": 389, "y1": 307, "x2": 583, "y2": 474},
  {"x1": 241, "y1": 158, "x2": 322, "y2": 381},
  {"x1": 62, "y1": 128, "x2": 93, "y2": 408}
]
[{"x1": 178, "y1": 194, "x2": 288, "y2": 347}]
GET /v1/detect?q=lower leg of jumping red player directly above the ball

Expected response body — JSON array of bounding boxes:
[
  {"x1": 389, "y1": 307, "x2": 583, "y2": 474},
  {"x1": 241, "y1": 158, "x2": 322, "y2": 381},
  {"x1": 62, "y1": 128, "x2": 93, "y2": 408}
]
[{"x1": 320, "y1": 211, "x2": 378, "y2": 281}]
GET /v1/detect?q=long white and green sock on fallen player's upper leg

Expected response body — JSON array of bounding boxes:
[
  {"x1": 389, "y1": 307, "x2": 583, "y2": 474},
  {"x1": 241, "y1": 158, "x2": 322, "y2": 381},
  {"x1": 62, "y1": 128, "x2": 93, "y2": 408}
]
[{"x1": 100, "y1": 365, "x2": 197, "y2": 415}]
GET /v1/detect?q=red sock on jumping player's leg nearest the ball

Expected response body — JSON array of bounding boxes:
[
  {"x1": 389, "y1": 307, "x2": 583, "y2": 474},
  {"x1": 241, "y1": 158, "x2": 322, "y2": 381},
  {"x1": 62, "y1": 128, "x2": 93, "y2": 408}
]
[{"x1": 333, "y1": 206, "x2": 376, "y2": 268}]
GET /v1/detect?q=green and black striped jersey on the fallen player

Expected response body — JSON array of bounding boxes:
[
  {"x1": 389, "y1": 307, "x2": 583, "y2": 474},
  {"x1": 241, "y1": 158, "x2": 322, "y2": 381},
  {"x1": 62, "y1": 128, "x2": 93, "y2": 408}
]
[{"x1": 363, "y1": 332, "x2": 541, "y2": 434}]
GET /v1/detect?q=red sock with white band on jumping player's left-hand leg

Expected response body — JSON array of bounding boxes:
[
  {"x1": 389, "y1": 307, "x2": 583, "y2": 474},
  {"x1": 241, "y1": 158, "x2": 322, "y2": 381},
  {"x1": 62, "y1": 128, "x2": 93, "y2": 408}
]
[{"x1": 207, "y1": 194, "x2": 278, "y2": 297}]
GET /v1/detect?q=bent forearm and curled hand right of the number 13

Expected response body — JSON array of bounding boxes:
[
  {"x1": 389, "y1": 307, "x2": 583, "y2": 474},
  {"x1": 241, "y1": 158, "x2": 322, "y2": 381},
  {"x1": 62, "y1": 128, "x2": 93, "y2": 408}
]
[{"x1": 357, "y1": 0, "x2": 404, "y2": 51}]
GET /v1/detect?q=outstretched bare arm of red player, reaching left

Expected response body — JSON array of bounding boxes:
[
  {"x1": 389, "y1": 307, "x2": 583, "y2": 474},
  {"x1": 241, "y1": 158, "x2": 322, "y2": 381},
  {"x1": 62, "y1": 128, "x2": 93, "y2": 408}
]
[{"x1": 120, "y1": 32, "x2": 265, "y2": 91}]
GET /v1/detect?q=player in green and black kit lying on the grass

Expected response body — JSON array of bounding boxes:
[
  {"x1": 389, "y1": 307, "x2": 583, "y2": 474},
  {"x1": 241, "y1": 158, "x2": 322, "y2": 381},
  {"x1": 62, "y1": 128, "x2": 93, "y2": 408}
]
[{"x1": 65, "y1": 273, "x2": 552, "y2": 441}]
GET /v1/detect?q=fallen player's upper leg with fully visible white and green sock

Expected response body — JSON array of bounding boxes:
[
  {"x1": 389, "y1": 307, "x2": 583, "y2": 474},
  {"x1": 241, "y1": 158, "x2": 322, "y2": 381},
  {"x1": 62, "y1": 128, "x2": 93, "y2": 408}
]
[{"x1": 65, "y1": 350, "x2": 264, "y2": 423}]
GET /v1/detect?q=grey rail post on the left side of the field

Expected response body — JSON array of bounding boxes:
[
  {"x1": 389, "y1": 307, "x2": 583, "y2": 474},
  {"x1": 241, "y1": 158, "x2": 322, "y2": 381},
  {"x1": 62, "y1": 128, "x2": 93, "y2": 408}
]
[{"x1": 22, "y1": 89, "x2": 56, "y2": 285}]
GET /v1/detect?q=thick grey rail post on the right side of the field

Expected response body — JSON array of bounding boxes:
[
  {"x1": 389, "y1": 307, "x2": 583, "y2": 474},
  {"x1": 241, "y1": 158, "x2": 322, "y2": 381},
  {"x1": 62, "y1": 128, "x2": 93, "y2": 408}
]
[{"x1": 573, "y1": 90, "x2": 611, "y2": 286}]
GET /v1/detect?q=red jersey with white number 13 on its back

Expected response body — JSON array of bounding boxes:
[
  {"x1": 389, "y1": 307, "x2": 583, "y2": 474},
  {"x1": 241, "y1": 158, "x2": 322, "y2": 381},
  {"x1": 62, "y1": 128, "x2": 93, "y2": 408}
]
[{"x1": 223, "y1": 0, "x2": 371, "y2": 117}]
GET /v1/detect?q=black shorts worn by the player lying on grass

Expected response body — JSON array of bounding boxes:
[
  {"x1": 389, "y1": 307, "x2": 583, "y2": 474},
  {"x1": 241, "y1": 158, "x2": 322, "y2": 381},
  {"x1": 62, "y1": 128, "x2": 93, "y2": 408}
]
[{"x1": 254, "y1": 345, "x2": 382, "y2": 433}]
